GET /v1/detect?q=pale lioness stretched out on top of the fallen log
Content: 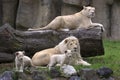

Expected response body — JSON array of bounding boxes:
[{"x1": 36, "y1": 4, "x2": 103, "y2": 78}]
[{"x1": 28, "y1": 6, "x2": 104, "y2": 31}]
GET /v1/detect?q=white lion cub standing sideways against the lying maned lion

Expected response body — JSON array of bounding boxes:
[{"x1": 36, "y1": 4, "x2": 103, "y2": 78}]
[{"x1": 48, "y1": 50, "x2": 72, "y2": 70}]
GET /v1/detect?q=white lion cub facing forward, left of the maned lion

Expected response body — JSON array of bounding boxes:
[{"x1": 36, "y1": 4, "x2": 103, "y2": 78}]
[{"x1": 15, "y1": 51, "x2": 32, "y2": 72}]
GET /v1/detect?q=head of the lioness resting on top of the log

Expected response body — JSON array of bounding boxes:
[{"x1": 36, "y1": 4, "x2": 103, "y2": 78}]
[{"x1": 83, "y1": 6, "x2": 95, "y2": 18}]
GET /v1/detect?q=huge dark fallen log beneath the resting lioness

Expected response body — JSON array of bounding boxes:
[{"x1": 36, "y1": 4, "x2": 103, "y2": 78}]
[{"x1": 0, "y1": 24, "x2": 104, "y2": 63}]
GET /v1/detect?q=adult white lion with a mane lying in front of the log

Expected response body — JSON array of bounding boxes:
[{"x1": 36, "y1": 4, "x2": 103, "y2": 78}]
[{"x1": 32, "y1": 36, "x2": 90, "y2": 66}]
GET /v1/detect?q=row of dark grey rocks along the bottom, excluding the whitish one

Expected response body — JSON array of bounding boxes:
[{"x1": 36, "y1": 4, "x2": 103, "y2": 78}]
[{"x1": 0, "y1": 68, "x2": 115, "y2": 80}]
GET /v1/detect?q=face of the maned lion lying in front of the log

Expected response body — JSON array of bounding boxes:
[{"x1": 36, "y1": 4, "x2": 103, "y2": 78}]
[{"x1": 65, "y1": 38, "x2": 79, "y2": 52}]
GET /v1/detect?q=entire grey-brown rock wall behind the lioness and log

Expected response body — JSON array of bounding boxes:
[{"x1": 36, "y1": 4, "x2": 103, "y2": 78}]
[{"x1": 0, "y1": 0, "x2": 120, "y2": 40}]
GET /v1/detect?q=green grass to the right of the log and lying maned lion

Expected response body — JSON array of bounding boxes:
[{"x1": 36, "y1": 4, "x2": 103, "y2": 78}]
[{"x1": 77, "y1": 40, "x2": 120, "y2": 78}]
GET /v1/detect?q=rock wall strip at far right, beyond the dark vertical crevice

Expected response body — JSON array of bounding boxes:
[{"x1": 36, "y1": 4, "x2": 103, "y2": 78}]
[{"x1": 111, "y1": 0, "x2": 120, "y2": 40}]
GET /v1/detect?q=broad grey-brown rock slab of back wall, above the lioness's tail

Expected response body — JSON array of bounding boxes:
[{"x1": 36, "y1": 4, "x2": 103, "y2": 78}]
[{"x1": 16, "y1": 0, "x2": 60, "y2": 30}]
